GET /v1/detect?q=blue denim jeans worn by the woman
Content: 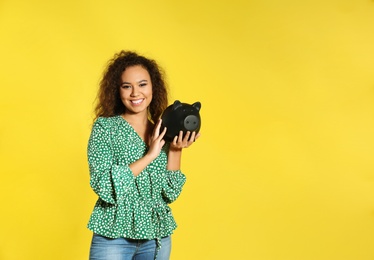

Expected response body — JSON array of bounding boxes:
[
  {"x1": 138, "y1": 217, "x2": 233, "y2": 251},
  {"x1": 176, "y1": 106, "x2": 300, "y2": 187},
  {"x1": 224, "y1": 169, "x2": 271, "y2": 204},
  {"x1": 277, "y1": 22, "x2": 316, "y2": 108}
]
[{"x1": 90, "y1": 234, "x2": 171, "y2": 260}]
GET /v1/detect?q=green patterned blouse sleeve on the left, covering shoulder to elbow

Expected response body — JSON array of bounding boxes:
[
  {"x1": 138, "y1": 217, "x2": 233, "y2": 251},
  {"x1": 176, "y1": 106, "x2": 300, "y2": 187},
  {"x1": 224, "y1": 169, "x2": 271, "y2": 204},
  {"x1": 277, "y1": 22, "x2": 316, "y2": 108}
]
[{"x1": 87, "y1": 118, "x2": 134, "y2": 204}]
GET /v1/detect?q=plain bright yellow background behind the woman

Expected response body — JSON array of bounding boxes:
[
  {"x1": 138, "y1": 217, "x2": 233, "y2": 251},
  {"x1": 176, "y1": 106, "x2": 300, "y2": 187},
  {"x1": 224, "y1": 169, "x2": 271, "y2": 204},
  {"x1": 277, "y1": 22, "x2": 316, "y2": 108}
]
[{"x1": 0, "y1": 0, "x2": 374, "y2": 260}]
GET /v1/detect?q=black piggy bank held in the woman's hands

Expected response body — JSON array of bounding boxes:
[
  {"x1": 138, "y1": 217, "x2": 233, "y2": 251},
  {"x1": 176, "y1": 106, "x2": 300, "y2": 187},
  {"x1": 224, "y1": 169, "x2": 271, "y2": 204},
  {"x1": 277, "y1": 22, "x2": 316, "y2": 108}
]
[{"x1": 161, "y1": 100, "x2": 201, "y2": 142}]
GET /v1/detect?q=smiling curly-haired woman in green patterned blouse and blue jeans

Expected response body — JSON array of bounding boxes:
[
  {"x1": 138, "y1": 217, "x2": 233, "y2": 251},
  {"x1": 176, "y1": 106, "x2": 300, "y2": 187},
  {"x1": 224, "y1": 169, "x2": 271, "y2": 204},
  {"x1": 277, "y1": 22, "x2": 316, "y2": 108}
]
[{"x1": 88, "y1": 51, "x2": 199, "y2": 260}]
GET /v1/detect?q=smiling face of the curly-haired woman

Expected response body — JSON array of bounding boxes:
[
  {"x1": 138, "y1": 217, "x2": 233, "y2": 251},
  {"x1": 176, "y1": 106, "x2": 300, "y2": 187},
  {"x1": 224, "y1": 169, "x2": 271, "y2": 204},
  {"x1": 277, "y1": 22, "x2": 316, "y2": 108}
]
[{"x1": 119, "y1": 65, "x2": 152, "y2": 114}]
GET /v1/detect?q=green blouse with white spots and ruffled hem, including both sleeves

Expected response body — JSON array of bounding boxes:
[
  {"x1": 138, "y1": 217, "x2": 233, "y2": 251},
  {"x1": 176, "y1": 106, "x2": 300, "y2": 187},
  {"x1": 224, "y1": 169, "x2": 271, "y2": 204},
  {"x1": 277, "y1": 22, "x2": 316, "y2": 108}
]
[{"x1": 87, "y1": 116, "x2": 186, "y2": 239}]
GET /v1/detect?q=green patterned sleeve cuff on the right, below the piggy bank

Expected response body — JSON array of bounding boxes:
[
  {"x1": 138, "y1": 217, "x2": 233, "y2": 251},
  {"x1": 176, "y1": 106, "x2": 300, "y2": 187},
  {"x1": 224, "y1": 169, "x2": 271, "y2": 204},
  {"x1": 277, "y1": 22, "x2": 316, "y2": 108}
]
[{"x1": 162, "y1": 170, "x2": 186, "y2": 203}]
